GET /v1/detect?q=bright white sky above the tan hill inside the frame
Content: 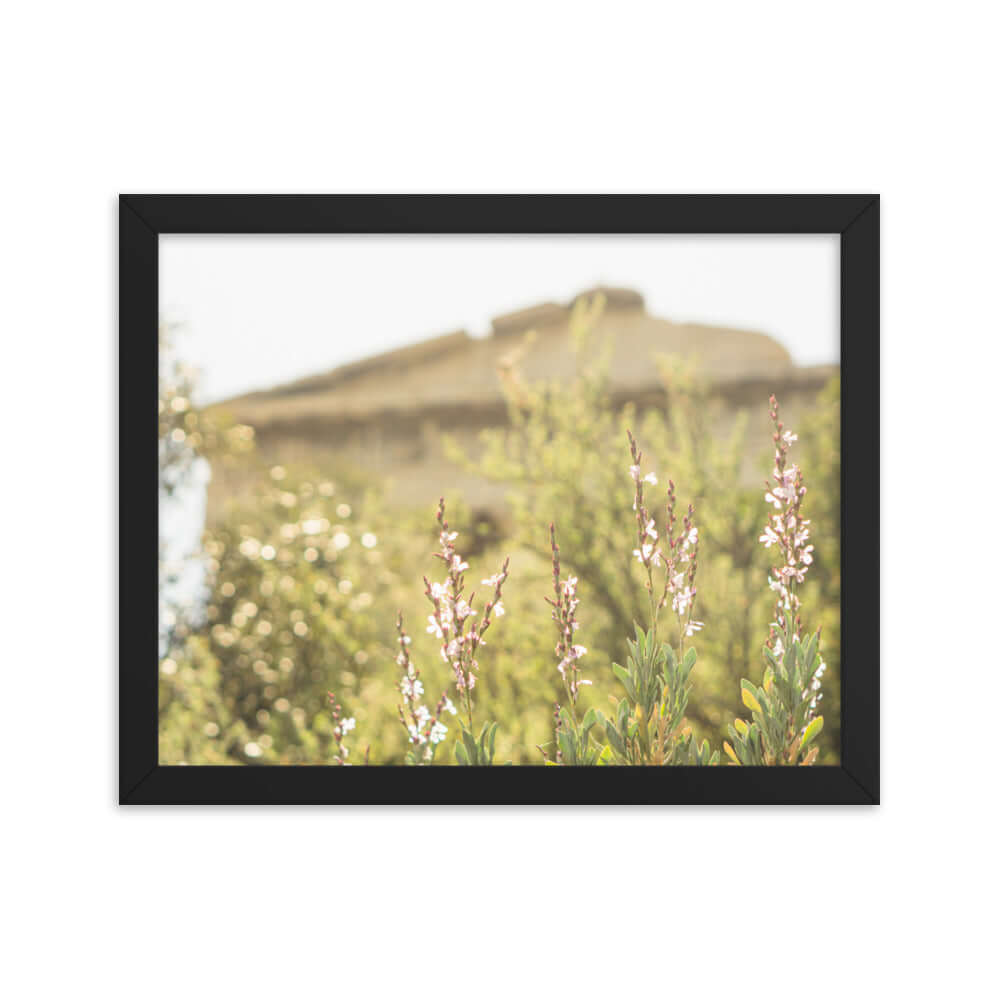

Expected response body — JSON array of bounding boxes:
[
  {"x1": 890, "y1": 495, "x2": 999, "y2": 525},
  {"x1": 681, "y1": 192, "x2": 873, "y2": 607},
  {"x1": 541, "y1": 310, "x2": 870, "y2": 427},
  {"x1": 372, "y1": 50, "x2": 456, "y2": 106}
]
[{"x1": 160, "y1": 235, "x2": 840, "y2": 403}]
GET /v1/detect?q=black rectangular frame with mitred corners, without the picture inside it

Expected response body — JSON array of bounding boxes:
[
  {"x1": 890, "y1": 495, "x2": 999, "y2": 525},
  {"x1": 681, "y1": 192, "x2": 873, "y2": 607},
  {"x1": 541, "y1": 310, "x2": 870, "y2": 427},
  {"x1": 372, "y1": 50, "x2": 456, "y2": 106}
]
[{"x1": 119, "y1": 195, "x2": 879, "y2": 804}]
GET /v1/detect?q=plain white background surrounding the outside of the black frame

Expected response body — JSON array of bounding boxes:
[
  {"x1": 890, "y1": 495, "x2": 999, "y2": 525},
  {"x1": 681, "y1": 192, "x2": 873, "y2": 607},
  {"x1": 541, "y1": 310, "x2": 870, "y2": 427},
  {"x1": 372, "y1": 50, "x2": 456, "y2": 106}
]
[{"x1": 0, "y1": 0, "x2": 1000, "y2": 998}]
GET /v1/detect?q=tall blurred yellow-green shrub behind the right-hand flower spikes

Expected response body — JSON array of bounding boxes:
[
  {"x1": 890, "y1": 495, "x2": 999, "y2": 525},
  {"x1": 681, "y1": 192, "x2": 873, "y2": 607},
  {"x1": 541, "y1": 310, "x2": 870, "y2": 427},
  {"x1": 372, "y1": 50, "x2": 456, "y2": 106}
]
[{"x1": 450, "y1": 303, "x2": 840, "y2": 763}]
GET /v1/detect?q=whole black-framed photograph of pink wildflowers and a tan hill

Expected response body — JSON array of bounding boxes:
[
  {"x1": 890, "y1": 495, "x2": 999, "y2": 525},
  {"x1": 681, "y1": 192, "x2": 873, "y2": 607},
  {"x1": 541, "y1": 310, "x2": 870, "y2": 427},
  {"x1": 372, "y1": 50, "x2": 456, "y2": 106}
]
[{"x1": 119, "y1": 195, "x2": 879, "y2": 804}]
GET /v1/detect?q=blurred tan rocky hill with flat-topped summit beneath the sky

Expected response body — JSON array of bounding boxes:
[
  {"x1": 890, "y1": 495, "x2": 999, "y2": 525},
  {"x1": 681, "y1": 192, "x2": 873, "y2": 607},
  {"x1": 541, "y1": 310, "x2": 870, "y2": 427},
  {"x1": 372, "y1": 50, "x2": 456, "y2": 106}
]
[{"x1": 209, "y1": 288, "x2": 837, "y2": 518}]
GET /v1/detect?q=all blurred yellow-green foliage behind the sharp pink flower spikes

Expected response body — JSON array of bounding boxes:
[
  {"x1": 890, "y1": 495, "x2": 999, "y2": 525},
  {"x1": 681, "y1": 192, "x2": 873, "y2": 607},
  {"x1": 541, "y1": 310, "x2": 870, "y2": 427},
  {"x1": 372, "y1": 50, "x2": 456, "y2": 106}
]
[{"x1": 160, "y1": 304, "x2": 840, "y2": 764}]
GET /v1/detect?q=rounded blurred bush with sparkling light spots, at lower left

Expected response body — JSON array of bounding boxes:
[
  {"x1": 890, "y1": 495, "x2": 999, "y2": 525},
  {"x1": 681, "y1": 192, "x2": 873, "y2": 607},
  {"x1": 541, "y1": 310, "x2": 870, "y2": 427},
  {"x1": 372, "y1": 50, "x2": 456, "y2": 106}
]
[{"x1": 161, "y1": 466, "x2": 443, "y2": 763}]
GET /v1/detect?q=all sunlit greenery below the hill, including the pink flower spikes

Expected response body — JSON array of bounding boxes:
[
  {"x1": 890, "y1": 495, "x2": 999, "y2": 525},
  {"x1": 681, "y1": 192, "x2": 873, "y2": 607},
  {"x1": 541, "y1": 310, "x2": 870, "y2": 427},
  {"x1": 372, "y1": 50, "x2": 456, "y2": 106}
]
[{"x1": 160, "y1": 303, "x2": 840, "y2": 765}]
